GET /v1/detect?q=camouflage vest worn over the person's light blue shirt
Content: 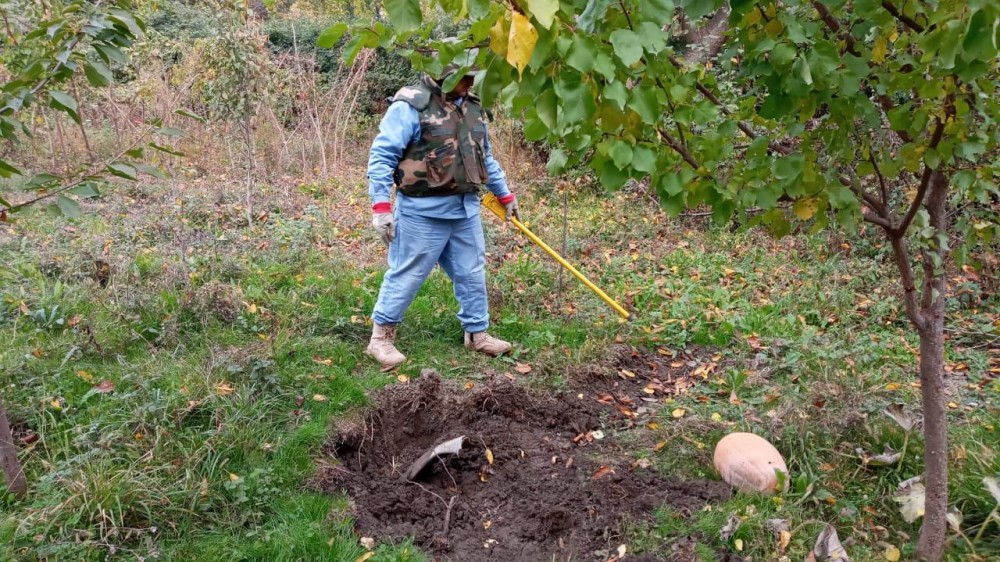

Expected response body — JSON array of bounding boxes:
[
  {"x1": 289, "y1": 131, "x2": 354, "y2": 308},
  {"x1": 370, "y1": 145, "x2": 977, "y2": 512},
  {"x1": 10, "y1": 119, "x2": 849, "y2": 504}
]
[{"x1": 392, "y1": 76, "x2": 489, "y2": 197}]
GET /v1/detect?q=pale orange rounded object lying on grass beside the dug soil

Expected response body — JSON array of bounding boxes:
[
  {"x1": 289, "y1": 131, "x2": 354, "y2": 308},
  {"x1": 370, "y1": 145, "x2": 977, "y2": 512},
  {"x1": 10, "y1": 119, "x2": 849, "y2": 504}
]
[{"x1": 715, "y1": 433, "x2": 788, "y2": 494}]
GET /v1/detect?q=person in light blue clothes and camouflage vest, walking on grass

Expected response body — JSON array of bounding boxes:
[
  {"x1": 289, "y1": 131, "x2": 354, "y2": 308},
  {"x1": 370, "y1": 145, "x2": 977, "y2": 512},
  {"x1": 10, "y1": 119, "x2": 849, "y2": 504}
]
[{"x1": 367, "y1": 66, "x2": 519, "y2": 369}]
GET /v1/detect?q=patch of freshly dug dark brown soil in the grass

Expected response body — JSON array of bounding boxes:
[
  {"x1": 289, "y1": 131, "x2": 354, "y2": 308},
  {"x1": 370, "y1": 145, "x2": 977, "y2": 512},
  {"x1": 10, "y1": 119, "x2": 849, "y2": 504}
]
[{"x1": 317, "y1": 373, "x2": 731, "y2": 562}]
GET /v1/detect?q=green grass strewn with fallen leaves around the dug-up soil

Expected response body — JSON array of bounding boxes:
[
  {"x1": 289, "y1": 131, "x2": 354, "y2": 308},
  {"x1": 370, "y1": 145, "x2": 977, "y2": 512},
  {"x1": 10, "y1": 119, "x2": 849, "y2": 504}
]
[{"x1": 0, "y1": 180, "x2": 1000, "y2": 561}]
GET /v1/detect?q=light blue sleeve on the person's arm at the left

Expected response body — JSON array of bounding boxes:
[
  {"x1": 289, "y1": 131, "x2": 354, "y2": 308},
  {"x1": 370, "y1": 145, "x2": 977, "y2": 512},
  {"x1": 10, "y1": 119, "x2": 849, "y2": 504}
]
[{"x1": 368, "y1": 101, "x2": 420, "y2": 205}]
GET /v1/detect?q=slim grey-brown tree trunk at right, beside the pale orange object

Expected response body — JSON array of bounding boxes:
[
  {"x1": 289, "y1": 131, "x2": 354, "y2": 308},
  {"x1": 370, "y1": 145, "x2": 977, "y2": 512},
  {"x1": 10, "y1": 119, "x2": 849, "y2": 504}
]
[{"x1": 917, "y1": 171, "x2": 949, "y2": 562}]
